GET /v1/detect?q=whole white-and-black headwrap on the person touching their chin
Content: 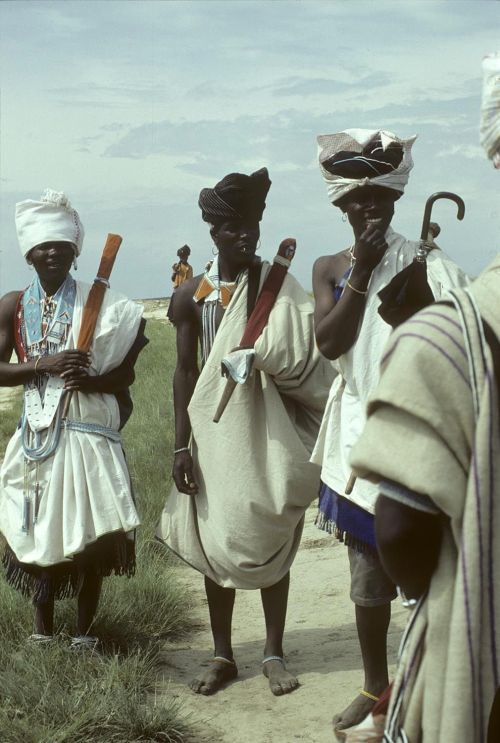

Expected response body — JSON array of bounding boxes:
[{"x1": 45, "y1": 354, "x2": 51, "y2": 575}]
[{"x1": 318, "y1": 129, "x2": 417, "y2": 204}]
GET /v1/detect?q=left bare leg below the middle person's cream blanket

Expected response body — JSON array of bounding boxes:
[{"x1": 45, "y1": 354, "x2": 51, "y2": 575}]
[{"x1": 189, "y1": 577, "x2": 238, "y2": 694}]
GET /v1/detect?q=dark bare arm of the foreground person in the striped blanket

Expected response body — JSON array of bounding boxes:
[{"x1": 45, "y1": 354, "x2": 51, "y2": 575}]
[{"x1": 375, "y1": 495, "x2": 443, "y2": 599}]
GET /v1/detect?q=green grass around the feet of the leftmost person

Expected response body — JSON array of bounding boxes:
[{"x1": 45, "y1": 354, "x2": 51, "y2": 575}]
[{"x1": 0, "y1": 321, "x2": 192, "y2": 743}]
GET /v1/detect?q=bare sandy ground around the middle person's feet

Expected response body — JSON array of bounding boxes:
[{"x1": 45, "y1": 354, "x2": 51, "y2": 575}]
[{"x1": 160, "y1": 506, "x2": 407, "y2": 743}]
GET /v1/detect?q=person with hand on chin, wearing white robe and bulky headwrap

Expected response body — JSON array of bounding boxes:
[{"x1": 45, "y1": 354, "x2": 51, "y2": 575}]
[{"x1": 312, "y1": 129, "x2": 467, "y2": 738}]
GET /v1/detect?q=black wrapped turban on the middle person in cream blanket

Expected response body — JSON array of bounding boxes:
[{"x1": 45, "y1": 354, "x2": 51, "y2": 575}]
[{"x1": 198, "y1": 168, "x2": 271, "y2": 224}]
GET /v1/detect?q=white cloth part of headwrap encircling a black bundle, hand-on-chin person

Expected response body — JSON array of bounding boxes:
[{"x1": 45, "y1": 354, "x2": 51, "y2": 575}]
[{"x1": 318, "y1": 129, "x2": 417, "y2": 203}]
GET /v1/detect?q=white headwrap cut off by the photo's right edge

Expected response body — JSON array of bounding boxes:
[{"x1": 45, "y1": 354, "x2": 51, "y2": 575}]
[{"x1": 479, "y1": 52, "x2": 500, "y2": 168}]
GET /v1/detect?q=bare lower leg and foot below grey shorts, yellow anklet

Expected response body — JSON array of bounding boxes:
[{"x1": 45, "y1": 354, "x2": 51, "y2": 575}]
[{"x1": 333, "y1": 603, "x2": 391, "y2": 739}]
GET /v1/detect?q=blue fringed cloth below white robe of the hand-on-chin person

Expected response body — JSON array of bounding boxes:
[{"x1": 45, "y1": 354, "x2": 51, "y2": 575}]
[{"x1": 316, "y1": 482, "x2": 377, "y2": 552}]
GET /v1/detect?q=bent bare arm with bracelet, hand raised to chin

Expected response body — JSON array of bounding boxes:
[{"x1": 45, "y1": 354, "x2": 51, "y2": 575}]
[{"x1": 313, "y1": 225, "x2": 387, "y2": 360}]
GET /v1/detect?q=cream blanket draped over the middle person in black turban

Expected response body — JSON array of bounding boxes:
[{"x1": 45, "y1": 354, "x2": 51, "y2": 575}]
[{"x1": 158, "y1": 271, "x2": 333, "y2": 589}]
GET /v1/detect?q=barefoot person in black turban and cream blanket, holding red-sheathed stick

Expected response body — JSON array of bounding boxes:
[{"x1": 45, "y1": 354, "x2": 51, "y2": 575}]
[{"x1": 158, "y1": 168, "x2": 332, "y2": 695}]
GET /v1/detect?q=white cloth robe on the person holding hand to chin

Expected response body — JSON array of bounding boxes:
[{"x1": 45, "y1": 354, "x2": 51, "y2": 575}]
[{"x1": 311, "y1": 227, "x2": 469, "y2": 513}]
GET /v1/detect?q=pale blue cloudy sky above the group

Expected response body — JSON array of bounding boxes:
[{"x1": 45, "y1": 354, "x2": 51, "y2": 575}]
[{"x1": 0, "y1": 0, "x2": 500, "y2": 298}]
